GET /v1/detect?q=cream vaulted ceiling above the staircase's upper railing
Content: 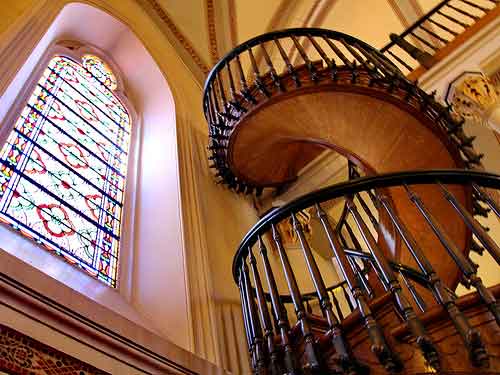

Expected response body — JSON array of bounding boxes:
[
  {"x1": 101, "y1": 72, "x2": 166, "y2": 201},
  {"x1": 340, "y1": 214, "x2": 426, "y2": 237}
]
[{"x1": 143, "y1": 0, "x2": 439, "y2": 82}]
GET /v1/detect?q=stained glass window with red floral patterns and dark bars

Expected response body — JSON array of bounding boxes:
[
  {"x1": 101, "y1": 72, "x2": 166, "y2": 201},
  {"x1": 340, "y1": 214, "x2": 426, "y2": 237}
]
[{"x1": 0, "y1": 55, "x2": 131, "y2": 287}]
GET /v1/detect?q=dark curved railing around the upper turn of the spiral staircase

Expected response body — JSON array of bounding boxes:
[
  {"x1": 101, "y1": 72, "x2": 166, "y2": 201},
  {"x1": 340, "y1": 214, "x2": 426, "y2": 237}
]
[{"x1": 203, "y1": 28, "x2": 481, "y2": 195}]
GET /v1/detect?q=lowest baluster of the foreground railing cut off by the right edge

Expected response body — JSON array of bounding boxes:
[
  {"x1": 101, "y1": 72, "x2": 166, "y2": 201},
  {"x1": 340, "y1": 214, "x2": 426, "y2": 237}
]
[{"x1": 405, "y1": 185, "x2": 500, "y2": 325}]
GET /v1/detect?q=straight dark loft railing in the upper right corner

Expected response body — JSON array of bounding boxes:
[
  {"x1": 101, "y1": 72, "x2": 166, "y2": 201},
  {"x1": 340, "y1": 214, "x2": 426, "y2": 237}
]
[{"x1": 380, "y1": 0, "x2": 499, "y2": 75}]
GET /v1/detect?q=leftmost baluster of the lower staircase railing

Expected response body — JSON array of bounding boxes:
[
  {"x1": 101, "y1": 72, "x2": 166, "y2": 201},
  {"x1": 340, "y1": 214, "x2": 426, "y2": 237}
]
[{"x1": 240, "y1": 260, "x2": 267, "y2": 375}]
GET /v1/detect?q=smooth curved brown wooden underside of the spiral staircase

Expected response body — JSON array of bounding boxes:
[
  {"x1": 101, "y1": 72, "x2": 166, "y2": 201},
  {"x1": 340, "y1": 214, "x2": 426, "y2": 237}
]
[{"x1": 228, "y1": 76, "x2": 470, "y2": 287}]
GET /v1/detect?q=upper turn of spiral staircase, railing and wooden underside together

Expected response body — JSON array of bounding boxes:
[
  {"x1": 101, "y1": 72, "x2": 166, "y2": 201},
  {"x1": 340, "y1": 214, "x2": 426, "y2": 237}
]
[{"x1": 203, "y1": 29, "x2": 480, "y2": 286}]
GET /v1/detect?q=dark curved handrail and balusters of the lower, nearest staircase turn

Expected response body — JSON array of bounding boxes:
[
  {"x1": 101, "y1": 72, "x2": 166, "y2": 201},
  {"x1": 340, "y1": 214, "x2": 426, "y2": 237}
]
[{"x1": 233, "y1": 170, "x2": 500, "y2": 374}]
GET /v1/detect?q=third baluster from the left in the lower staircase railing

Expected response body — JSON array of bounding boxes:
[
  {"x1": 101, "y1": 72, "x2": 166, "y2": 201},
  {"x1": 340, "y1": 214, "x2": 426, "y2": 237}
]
[{"x1": 259, "y1": 237, "x2": 299, "y2": 375}]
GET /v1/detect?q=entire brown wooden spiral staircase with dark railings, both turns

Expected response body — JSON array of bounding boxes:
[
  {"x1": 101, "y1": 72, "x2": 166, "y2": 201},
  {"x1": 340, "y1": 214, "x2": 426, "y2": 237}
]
[{"x1": 203, "y1": 2, "x2": 500, "y2": 374}]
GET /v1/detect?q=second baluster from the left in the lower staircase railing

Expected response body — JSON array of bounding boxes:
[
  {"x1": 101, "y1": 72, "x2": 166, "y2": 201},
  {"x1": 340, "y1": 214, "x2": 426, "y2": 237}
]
[{"x1": 248, "y1": 246, "x2": 281, "y2": 375}]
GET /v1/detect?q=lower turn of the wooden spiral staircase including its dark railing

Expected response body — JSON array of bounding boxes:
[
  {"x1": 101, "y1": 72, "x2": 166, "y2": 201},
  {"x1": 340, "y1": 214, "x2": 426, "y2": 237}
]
[{"x1": 233, "y1": 170, "x2": 500, "y2": 375}]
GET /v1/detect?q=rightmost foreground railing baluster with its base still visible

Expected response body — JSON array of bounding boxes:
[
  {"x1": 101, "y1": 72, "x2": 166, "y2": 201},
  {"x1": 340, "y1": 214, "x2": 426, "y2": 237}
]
[{"x1": 378, "y1": 195, "x2": 488, "y2": 366}]
